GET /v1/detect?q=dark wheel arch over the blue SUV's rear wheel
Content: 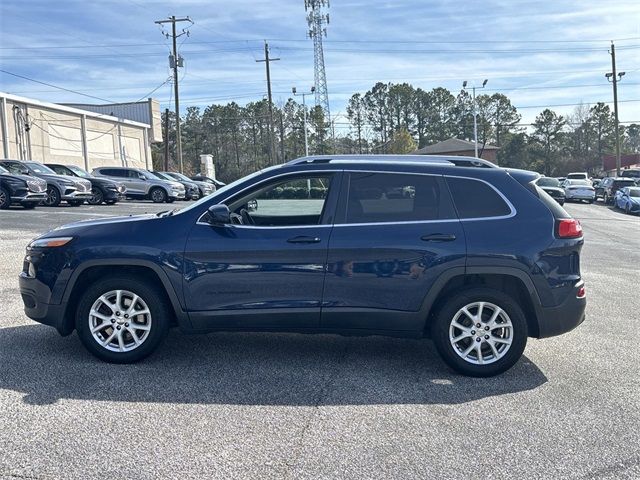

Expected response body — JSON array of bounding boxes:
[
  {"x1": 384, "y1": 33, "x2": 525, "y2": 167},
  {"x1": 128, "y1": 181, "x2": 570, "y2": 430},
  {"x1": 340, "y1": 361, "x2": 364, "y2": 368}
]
[{"x1": 421, "y1": 267, "x2": 541, "y2": 337}]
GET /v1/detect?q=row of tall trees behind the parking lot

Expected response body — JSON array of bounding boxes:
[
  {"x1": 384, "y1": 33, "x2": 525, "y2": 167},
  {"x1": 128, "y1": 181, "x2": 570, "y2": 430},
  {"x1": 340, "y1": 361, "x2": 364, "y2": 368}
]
[{"x1": 152, "y1": 82, "x2": 640, "y2": 181}]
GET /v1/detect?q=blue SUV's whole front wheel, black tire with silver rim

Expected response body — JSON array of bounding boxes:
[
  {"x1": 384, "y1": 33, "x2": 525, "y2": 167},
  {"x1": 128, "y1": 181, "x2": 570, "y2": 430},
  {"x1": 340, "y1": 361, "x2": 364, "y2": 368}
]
[{"x1": 75, "y1": 276, "x2": 172, "y2": 363}]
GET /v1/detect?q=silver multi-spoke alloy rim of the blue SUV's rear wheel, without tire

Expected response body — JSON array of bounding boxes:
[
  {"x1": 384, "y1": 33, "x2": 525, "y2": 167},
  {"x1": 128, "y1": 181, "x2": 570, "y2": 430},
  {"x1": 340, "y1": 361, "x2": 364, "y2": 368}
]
[{"x1": 449, "y1": 302, "x2": 514, "y2": 365}]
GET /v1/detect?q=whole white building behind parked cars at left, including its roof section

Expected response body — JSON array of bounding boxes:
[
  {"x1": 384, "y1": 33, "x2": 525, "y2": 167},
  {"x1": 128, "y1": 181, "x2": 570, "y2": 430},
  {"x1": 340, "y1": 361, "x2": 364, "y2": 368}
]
[{"x1": 0, "y1": 92, "x2": 162, "y2": 171}]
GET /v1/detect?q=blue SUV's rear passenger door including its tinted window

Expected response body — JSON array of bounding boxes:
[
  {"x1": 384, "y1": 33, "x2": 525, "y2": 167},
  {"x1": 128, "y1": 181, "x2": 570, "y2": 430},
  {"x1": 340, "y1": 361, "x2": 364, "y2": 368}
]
[{"x1": 321, "y1": 172, "x2": 466, "y2": 331}]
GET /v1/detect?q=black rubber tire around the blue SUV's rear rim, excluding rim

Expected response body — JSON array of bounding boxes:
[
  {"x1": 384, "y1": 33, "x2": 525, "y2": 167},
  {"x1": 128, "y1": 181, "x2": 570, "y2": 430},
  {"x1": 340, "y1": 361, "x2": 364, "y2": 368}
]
[{"x1": 431, "y1": 288, "x2": 528, "y2": 377}]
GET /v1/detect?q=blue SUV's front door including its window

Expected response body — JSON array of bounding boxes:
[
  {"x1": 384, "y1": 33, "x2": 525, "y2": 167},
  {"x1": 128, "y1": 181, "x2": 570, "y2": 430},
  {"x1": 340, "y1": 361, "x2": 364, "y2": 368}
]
[{"x1": 184, "y1": 172, "x2": 340, "y2": 329}]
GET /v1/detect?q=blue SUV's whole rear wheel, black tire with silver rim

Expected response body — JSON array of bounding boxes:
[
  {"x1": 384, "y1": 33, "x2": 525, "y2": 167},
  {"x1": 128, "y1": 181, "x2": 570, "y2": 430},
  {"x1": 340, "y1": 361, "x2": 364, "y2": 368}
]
[{"x1": 431, "y1": 288, "x2": 528, "y2": 377}]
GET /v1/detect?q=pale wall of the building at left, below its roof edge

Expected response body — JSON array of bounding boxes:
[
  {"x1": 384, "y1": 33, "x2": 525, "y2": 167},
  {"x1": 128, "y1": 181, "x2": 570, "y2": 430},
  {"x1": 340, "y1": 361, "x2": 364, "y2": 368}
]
[{"x1": 0, "y1": 93, "x2": 151, "y2": 171}]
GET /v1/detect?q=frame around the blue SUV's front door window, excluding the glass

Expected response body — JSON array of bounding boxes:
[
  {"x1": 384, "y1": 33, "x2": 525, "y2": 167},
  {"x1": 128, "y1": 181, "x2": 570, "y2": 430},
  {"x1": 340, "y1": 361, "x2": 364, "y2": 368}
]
[{"x1": 196, "y1": 169, "x2": 344, "y2": 230}]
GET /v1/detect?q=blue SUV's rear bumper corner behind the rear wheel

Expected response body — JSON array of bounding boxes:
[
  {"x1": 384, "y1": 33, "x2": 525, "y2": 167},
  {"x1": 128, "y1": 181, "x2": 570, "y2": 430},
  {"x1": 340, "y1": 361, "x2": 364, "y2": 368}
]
[{"x1": 538, "y1": 280, "x2": 587, "y2": 338}]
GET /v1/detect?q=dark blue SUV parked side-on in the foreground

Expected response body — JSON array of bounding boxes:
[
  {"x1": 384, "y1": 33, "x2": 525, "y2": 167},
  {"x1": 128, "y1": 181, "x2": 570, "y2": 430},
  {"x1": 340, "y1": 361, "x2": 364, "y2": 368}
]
[{"x1": 20, "y1": 155, "x2": 586, "y2": 376}]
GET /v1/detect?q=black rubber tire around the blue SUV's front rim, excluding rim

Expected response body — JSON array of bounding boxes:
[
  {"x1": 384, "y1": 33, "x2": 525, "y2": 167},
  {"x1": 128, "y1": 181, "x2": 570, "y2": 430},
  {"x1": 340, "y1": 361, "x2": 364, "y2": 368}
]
[{"x1": 75, "y1": 277, "x2": 170, "y2": 363}]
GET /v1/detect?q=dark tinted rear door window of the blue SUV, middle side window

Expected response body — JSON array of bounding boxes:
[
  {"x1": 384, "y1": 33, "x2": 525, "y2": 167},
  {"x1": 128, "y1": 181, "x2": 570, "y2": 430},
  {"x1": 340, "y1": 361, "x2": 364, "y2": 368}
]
[{"x1": 345, "y1": 172, "x2": 455, "y2": 223}]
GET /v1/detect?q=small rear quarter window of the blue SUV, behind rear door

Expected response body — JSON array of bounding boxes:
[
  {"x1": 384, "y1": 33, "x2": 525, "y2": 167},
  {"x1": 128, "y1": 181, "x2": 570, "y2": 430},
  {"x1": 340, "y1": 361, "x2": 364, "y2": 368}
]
[{"x1": 447, "y1": 177, "x2": 511, "y2": 218}]
